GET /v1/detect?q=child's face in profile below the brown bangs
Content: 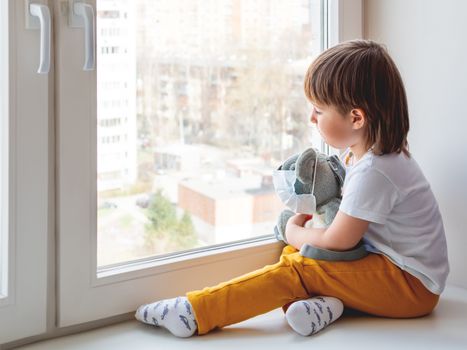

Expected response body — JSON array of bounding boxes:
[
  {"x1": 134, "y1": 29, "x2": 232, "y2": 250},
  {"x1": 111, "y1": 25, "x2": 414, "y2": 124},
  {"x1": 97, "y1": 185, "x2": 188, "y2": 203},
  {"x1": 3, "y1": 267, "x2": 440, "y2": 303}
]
[{"x1": 310, "y1": 103, "x2": 363, "y2": 149}]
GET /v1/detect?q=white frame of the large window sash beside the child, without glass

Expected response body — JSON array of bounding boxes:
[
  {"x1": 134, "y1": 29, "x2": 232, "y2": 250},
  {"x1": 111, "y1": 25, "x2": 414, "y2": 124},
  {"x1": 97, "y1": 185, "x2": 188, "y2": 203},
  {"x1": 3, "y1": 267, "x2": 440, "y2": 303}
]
[{"x1": 55, "y1": 0, "x2": 362, "y2": 327}]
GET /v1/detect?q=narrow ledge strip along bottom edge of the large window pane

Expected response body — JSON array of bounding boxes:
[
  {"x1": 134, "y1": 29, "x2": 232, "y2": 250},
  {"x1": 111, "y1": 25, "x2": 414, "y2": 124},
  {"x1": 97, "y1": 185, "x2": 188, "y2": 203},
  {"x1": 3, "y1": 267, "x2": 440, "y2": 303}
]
[{"x1": 93, "y1": 236, "x2": 283, "y2": 286}]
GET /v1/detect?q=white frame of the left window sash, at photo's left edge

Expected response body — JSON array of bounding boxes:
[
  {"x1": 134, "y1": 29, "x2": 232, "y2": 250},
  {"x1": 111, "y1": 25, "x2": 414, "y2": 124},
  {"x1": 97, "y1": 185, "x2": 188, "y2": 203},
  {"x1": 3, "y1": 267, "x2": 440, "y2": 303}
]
[{"x1": 0, "y1": 0, "x2": 53, "y2": 344}]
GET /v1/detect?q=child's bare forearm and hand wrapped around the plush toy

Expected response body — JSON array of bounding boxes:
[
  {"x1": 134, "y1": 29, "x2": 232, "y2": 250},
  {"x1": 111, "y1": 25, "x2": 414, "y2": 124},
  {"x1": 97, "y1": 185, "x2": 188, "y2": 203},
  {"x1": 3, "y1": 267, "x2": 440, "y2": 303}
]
[{"x1": 285, "y1": 210, "x2": 369, "y2": 251}]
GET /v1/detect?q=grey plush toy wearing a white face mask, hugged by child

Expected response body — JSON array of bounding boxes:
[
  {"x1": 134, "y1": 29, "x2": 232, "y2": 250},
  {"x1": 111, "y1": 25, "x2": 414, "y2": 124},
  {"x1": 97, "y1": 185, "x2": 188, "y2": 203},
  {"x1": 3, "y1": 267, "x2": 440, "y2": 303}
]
[{"x1": 273, "y1": 148, "x2": 367, "y2": 260}]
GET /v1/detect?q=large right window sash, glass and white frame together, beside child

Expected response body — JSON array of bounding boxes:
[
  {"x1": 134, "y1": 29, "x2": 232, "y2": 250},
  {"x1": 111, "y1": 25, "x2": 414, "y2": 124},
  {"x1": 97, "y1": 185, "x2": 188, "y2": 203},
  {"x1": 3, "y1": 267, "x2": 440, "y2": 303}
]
[{"x1": 54, "y1": 0, "x2": 361, "y2": 327}]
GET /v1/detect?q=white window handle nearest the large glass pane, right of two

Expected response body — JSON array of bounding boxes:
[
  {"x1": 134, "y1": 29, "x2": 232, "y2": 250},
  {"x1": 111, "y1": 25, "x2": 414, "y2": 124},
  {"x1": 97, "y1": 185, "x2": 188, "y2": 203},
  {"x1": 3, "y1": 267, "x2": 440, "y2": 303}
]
[{"x1": 71, "y1": 1, "x2": 96, "y2": 70}]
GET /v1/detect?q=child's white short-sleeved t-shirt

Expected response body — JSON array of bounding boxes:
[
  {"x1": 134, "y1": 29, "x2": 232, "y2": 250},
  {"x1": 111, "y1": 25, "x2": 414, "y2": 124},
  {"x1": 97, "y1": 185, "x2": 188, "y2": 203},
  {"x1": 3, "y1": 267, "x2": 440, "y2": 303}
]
[{"x1": 339, "y1": 149, "x2": 449, "y2": 294}]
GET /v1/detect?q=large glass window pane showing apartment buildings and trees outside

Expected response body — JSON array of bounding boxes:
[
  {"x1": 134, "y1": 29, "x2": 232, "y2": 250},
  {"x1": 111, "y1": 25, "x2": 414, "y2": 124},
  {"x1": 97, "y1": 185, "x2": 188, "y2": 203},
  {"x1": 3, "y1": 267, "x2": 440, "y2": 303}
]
[{"x1": 97, "y1": 0, "x2": 322, "y2": 266}]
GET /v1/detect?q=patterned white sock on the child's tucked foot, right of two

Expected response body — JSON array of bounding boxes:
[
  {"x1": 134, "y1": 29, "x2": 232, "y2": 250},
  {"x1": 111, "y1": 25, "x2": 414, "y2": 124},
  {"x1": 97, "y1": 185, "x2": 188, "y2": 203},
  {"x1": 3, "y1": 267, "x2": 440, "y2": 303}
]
[{"x1": 285, "y1": 297, "x2": 344, "y2": 336}]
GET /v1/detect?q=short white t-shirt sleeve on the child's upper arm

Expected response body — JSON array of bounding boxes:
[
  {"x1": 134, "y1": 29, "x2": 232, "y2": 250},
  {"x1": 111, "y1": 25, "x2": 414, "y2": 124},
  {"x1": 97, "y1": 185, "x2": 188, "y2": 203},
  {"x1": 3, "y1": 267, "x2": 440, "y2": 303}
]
[{"x1": 339, "y1": 169, "x2": 399, "y2": 224}]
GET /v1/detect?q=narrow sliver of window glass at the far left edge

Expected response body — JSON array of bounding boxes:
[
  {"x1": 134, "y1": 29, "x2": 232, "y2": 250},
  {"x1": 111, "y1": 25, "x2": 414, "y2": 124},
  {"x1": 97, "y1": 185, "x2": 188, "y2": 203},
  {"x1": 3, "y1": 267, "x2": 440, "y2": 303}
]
[{"x1": 0, "y1": 1, "x2": 8, "y2": 299}]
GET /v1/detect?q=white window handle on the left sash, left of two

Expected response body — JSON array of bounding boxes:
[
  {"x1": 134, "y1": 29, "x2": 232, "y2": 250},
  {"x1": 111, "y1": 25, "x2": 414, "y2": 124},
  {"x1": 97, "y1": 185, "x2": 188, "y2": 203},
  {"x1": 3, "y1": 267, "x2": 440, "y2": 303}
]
[{"x1": 29, "y1": 4, "x2": 51, "y2": 74}]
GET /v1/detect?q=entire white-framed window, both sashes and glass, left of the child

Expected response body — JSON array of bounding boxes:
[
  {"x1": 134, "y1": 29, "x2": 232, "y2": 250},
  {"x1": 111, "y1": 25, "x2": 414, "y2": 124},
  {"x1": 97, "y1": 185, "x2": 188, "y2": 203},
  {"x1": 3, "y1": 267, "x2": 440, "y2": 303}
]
[{"x1": 0, "y1": 0, "x2": 361, "y2": 343}]
